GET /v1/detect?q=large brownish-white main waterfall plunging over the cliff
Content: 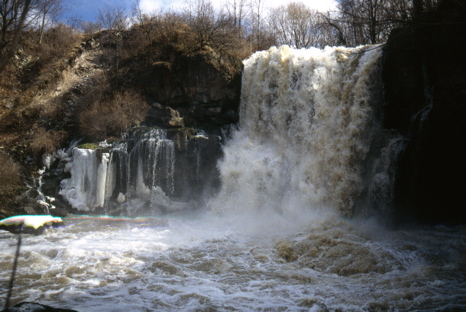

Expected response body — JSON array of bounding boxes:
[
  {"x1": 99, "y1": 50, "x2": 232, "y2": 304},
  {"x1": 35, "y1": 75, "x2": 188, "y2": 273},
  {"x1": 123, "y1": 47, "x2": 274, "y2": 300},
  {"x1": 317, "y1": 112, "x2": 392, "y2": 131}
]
[{"x1": 211, "y1": 46, "x2": 395, "y2": 216}]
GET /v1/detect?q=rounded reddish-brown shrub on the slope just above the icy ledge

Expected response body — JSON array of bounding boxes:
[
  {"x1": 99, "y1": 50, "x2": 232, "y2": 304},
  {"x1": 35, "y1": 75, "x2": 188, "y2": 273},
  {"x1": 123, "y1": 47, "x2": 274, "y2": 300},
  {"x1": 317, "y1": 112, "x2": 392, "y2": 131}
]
[{"x1": 78, "y1": 91, "x2": 149, "y2": 140}]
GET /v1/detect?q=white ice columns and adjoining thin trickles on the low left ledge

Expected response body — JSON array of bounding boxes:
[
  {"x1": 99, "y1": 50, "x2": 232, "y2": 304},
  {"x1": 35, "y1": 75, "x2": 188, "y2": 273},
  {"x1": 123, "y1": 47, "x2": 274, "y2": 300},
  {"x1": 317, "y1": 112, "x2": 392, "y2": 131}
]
[{"x1": 60, "y1": 128, "x2": 175, "y2": 211}]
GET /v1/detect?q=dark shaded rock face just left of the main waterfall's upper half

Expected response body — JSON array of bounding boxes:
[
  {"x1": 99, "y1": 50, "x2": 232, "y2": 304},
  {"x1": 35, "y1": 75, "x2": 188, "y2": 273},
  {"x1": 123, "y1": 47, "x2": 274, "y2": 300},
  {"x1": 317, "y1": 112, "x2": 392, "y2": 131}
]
[{"x1": 140, "y1": 52, "x2": 241, "y2": 128}]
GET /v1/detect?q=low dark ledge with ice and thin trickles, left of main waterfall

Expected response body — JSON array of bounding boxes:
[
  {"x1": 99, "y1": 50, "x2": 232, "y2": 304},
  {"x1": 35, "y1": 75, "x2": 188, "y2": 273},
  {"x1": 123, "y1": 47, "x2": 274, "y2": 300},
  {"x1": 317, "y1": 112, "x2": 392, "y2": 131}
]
[{"x1": 59, "y1": 127, "x2": 221, "y2": 216}]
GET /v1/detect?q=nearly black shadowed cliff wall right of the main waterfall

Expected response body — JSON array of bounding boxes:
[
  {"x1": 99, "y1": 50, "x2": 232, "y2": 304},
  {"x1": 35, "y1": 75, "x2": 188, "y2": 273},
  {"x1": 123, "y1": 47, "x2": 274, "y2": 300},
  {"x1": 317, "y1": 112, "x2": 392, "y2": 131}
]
[{"x1": 383, "y1": 1, "x2": 466, "y2": 223}]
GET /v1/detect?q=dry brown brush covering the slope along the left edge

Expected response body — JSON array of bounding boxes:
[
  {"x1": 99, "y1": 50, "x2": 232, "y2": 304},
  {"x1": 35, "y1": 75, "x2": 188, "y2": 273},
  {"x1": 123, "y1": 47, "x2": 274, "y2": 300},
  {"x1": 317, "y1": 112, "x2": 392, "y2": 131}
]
[{"x1": 0, "y1": 21, "x2": 81, "y2": 213}]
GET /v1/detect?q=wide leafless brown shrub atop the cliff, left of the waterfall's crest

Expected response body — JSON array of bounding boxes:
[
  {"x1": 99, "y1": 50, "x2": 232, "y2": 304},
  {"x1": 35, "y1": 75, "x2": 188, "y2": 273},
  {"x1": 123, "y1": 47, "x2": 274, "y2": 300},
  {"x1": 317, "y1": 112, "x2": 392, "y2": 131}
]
[{"x1": 123, "y1": 8, "x2": 251, "y2": 66}]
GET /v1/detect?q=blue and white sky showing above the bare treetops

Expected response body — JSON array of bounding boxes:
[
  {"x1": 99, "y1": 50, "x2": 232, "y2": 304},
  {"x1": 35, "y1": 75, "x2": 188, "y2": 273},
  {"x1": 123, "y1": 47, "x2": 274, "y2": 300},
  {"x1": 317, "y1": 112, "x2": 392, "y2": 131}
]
[{"x1": 63, "y1": 0, "x2": 336, "y2": 21}]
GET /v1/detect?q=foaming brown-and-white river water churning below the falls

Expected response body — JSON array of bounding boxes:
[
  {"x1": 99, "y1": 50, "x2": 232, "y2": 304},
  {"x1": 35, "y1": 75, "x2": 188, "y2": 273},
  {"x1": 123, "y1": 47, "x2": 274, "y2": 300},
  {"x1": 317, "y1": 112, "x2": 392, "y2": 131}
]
[{"x1": 0, "y1": 215, "x2": 466, "y2": 312}]
